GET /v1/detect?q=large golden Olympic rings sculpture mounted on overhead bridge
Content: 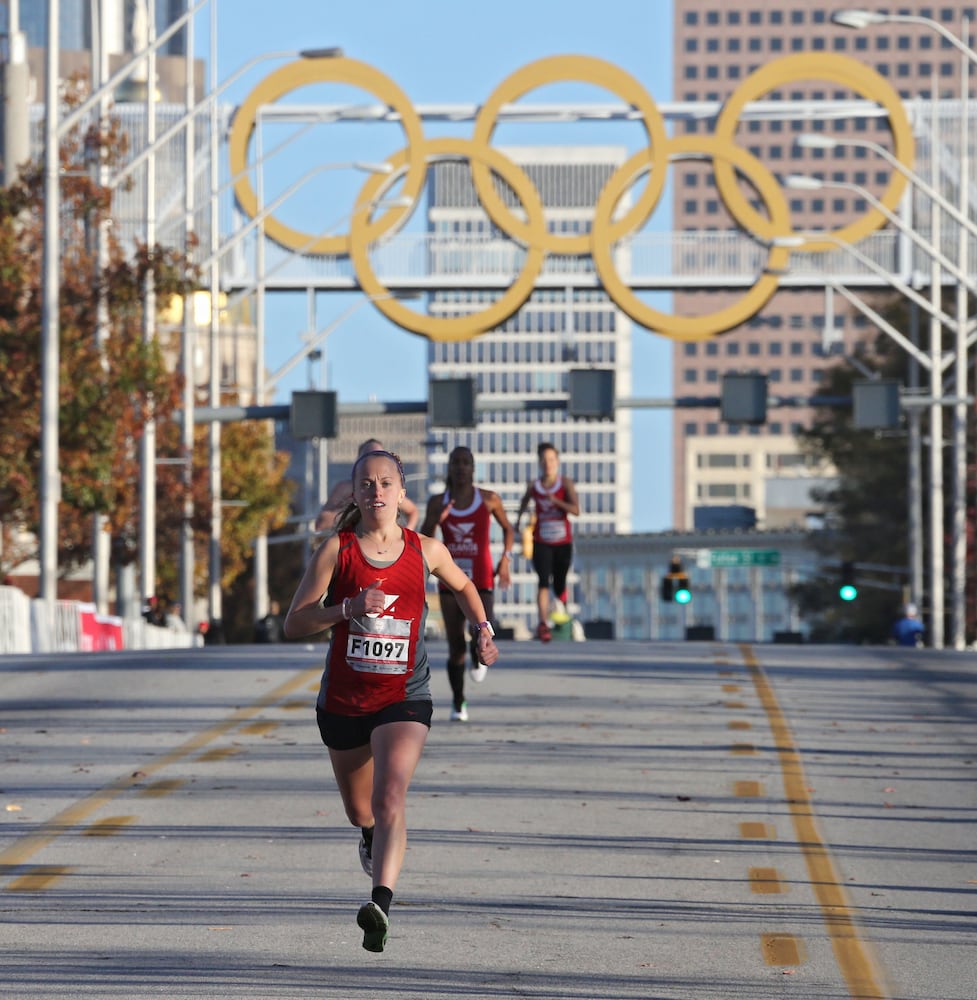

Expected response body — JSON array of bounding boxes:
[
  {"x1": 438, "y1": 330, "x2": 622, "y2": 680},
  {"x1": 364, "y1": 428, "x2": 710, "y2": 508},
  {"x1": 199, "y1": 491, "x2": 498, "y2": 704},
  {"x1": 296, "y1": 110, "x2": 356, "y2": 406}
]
[{"x1": 229, "y1": 53, "x2": 914, "y2": 341}]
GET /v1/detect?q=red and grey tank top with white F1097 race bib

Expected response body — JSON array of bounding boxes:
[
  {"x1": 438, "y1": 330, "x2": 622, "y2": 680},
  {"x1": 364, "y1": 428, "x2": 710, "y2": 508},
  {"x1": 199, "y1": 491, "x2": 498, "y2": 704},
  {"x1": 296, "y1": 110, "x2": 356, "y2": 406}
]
[{"x1": 318, "y1": 528, "x2": 430, "y2": 715}]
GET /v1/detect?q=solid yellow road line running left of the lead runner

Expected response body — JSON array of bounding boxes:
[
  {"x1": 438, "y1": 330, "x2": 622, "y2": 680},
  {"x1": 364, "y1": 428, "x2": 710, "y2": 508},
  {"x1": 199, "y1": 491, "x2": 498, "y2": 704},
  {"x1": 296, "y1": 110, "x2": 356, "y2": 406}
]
[{"x1": 0, "y1": 667, "x2": 322, "y2": 872}]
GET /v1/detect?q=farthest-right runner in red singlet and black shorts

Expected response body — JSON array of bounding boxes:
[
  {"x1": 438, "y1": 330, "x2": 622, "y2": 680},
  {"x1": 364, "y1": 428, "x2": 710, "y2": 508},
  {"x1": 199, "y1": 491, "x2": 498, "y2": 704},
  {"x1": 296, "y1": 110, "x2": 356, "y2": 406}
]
[{"x1": 516, "y1": 442, "x2": 580, "y2": 642}]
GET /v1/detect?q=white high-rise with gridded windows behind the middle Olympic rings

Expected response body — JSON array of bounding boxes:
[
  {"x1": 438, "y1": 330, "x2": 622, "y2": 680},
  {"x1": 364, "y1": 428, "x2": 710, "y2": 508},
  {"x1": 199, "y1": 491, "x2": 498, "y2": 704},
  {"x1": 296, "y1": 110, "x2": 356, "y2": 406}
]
[{"x1": 428, "y1": 147, "x2": 632, "y2": 625}]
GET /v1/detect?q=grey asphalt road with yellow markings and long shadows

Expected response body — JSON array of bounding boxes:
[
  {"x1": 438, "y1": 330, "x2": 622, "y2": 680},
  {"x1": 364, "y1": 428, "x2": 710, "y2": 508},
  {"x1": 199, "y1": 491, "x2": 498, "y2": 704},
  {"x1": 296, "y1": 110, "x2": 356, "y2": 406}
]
[{"x1": 0, "y1": 642, "x2": 977, "y2": 1000}]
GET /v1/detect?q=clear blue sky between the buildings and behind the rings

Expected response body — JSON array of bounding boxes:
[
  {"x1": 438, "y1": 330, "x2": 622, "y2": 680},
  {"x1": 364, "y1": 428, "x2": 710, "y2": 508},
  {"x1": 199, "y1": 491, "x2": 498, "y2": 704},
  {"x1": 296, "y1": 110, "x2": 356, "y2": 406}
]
[{"x1": 204, "y1": 0, "x2": 672, "y2": 531}]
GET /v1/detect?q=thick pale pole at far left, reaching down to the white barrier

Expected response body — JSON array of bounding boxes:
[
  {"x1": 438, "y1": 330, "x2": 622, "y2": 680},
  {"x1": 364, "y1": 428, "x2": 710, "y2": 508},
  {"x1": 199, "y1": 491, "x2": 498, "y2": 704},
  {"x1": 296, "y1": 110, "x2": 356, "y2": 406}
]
[{"x1": 39, "y1": 0, "x2": 61, "y2": 613}]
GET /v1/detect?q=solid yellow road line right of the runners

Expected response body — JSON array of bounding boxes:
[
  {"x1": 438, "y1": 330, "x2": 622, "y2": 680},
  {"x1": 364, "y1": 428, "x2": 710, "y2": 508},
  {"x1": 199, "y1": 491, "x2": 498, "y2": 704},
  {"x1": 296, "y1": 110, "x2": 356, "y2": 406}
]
[{"x1": 740, "y1": 644, "x2": 886, "y2": 1000}]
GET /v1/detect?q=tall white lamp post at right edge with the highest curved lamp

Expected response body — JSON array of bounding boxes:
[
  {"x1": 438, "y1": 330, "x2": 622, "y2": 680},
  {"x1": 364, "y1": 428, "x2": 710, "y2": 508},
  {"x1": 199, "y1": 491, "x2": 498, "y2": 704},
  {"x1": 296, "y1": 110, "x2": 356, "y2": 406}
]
[{"x1": 831, "y1": 8, "x2": 977, "y2": 650}]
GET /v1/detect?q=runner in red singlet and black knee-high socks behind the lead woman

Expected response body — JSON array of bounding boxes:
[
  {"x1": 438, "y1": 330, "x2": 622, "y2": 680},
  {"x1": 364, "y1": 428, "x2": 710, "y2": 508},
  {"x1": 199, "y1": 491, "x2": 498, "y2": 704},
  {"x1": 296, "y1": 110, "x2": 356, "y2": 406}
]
[{"x1": 421, "y1": 446, "x2": 515, "y2": 722}]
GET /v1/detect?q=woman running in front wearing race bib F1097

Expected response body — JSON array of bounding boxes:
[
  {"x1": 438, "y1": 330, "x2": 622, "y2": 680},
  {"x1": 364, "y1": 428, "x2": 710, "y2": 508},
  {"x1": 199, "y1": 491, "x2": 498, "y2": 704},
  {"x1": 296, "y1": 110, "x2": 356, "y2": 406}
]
[{"x1": 285, "y1": 451, "x2": 499, "y2": 951}]
